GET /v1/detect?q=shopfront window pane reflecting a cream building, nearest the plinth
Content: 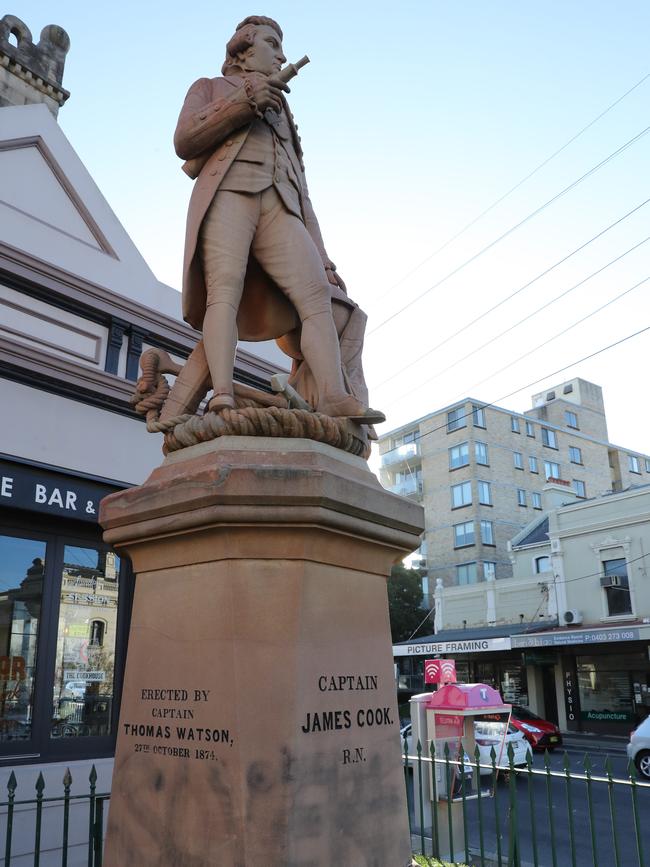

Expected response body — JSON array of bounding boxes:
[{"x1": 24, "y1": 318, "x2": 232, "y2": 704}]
[{"x1": 51, "y1": 545, "x2": 120, "y2": 738}]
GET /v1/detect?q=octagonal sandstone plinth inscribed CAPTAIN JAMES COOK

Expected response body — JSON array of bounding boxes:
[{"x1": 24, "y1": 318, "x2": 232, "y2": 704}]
[{"x1": 100, "y1": 437, "x2": 423, "y2": 867}]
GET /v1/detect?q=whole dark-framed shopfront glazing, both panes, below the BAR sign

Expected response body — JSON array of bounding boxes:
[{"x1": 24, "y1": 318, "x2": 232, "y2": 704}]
[{"x1": 0, "y1": 523, "x2": 130, "y2": 761}]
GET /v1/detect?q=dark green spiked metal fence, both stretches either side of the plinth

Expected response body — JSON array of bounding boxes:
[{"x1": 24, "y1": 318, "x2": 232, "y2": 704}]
[{"x1": 0, "y1": 743, "x2": 650, "y2": 867}]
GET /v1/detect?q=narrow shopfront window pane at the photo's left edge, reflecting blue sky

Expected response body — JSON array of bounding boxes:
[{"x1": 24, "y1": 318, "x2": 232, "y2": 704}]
[{"x1": 0, "y1": 535, "x2": 46, "y2": 743}]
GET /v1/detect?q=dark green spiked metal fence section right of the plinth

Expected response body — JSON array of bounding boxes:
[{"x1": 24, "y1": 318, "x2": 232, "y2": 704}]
[{"x1": 404, "y1": 741, "x2": 650, "y2": 867}]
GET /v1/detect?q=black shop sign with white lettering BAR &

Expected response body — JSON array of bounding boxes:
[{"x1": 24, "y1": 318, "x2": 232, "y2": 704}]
[{"x1": 0, "y1": 461, "x2": 115, "y2": 523}]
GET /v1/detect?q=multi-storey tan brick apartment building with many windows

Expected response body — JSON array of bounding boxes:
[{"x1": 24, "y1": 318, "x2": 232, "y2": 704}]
[{"x1": 379, "y1": 379, "x2": 650, "y2": 608}]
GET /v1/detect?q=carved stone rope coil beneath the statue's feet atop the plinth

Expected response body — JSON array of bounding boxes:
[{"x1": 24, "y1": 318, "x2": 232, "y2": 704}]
[{"x1": 158, "y1": 406, "x2": 370, "y2": 458}]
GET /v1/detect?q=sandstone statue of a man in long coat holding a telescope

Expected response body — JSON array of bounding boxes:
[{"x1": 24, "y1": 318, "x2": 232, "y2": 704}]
[{"x1": 174, "y1": 16, "x2": 384, "y2": 424}]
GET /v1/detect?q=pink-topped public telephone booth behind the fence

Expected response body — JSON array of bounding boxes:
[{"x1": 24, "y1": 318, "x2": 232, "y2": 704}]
[{"x1": 410, "y1": 683, "x2": 512, "y2": 858}]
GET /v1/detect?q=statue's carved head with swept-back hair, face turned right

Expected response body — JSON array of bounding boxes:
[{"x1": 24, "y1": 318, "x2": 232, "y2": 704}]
[{"x1": 221, "y1": 15, "x2": 286, "y2": 75}]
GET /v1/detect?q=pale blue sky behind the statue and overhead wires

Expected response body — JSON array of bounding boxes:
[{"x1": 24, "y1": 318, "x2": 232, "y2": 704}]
[{"x1": 15, "y1": 0, "x2": 650, "y2": 452}]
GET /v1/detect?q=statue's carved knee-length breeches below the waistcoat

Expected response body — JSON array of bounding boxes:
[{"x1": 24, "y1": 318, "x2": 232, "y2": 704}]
[{"x1": 199, "y1": 187, "x2": 332, "y2": 321}]
